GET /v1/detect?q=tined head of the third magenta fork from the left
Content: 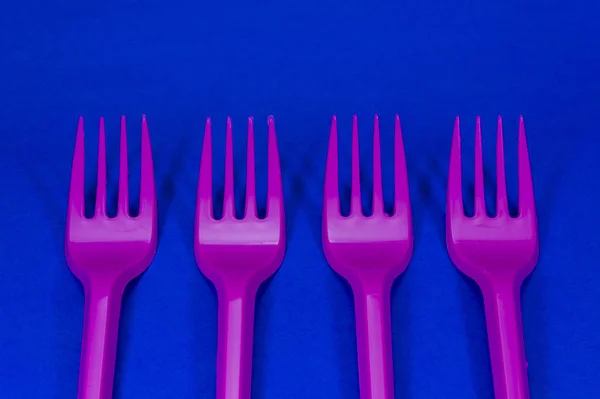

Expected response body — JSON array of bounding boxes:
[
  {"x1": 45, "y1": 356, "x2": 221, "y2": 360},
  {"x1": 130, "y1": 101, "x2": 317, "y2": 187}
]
[{"x1": 322, "y1": 116, "x2": 413, "y2": 285}]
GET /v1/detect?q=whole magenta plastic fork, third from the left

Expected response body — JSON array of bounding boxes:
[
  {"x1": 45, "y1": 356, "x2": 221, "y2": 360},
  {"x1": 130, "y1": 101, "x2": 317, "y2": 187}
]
[{"x1": 323, "y1": 116, "x2": 413, "y2": 399}]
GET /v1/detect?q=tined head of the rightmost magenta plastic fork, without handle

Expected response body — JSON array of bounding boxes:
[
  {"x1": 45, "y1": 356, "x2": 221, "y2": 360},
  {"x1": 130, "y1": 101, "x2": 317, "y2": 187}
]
[{"x1": 446, "y1": 117, "x2": 539, "y2": 283}]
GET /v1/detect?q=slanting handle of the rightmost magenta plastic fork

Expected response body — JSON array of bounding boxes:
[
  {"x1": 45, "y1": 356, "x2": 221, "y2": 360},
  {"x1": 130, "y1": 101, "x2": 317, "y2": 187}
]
[{"x1": 483, "y1": 282, "x2": 529, "y2": 399}]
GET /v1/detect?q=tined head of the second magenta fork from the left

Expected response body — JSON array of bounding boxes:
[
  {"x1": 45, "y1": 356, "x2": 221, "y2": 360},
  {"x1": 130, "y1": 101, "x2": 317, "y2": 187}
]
[{"x1": 194, "y1": 116, "x2": 285, "y2": 288}]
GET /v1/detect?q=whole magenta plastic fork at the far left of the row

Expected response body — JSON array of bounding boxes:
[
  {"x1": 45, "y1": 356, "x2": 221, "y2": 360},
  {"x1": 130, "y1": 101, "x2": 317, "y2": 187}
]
[{"x1": 65, "y1": 116, "x2": 157, "y2": 399}]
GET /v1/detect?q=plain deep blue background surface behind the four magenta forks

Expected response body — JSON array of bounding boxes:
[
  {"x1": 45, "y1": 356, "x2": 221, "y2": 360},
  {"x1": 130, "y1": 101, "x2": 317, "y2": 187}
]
[{"x1": 0, "y1": 0, "x2": 600, "y2": 399}]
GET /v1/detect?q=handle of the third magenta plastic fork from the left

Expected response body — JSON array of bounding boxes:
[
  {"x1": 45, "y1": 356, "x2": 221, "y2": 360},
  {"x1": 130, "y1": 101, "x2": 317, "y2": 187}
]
[{"x1": 354, "y1": 284, "x2": 394, "y2": 399}]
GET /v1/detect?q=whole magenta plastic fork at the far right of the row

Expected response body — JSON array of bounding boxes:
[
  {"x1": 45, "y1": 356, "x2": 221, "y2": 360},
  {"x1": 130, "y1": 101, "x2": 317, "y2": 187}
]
[{"x1": 446, "y1": 117, "x2": 539, "y2": 399}]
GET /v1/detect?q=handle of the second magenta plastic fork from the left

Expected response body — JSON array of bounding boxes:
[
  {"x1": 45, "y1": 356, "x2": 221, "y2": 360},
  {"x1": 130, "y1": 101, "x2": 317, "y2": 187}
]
[{"x1": 217, "y1": 287, "x2": 256, "y2": 399}]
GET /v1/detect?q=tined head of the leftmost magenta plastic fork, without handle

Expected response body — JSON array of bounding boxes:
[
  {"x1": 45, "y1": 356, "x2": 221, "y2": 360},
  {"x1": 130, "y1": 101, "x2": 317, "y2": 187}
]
[{"x1": 65, "y1": 116, "x2": 157, "y2": 285}]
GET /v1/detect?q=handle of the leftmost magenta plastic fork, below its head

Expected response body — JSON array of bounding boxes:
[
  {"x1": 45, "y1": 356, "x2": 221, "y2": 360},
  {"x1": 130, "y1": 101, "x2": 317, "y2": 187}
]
[{"x1": 77, "y1": 284, "x2": 123, "y2": 399}]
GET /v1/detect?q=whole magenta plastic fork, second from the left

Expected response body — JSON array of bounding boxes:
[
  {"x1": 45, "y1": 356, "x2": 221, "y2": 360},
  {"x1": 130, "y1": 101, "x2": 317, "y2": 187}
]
[{"x1": 194, "y1": 117, "x2": 285, "y2": 399}]
